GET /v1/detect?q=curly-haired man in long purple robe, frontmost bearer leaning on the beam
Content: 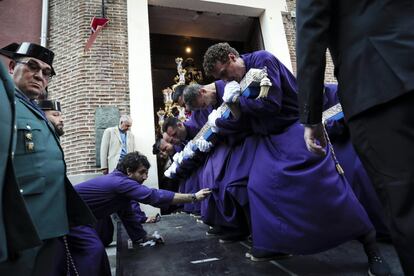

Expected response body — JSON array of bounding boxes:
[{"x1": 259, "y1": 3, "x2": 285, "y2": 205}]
[{"x1": 203, "y1": 43, "x2": 390, "y2": 275}]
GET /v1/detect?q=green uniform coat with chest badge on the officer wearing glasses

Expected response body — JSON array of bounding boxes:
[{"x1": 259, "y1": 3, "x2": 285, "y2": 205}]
[{"x1": 14, "y1": 90, "x2": 95, "y2": 240}]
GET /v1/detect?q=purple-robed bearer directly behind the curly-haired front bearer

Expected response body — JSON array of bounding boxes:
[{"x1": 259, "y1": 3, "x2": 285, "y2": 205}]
[{"x1": 184, "y1": 81, "x2": 257, "y2": 243}]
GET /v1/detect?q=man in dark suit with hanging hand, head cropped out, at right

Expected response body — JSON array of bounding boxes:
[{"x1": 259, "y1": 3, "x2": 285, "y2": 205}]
[{"x1": 296, "y1": 0, "x2": 414, "y2": 275}]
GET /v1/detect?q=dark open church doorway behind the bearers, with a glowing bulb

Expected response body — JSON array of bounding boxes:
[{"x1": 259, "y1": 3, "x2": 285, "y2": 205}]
[{"x1": 148, "y1": 6, "x2": 264, "y2": 205}]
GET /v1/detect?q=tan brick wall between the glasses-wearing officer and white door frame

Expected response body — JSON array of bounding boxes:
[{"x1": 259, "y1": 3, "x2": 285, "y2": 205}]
[{"x1": 48, "y1": 0, "x2": 129, "y2": 175}]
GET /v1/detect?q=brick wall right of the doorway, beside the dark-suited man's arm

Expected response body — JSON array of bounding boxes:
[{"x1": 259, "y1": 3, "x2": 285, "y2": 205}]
[{"x1": 283, "y1": 0, "x2": 337, "y2": 83}]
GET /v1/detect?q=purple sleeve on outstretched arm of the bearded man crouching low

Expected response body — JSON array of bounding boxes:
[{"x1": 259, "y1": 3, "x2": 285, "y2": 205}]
[{"x1": 117, "y1": 177, "x2": 174, "y2": 207}]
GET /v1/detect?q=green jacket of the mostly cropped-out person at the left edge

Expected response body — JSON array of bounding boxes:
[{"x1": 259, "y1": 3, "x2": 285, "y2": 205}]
[{"x1": 0, "y1": 62, "x2": 41, "y2": 262}]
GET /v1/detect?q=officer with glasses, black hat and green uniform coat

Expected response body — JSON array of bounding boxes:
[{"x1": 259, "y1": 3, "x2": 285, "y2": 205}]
[{"x1": 0, "y1": 42, "x2": 95, "y2": 276}]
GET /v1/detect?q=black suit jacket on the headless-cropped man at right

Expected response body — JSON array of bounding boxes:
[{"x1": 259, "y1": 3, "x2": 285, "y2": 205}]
[{"x1": 296, "y1": 0, "x2": 414, "y2": 124}]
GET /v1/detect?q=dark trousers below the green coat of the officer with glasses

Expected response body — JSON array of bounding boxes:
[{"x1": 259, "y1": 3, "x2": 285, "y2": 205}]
[{"x1": 0, "y1": 238, "x2": 63, "y2": 276}]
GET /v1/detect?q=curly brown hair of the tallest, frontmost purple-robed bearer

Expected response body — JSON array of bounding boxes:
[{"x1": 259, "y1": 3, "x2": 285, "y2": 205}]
[{"x1": 203, "y1": 42, "x2": 239, "y2": 76}]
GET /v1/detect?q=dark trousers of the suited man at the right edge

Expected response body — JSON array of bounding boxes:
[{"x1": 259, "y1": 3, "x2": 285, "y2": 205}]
[{"x1": 348, "y1": 91, "x2": 414, "y2": 276}]
